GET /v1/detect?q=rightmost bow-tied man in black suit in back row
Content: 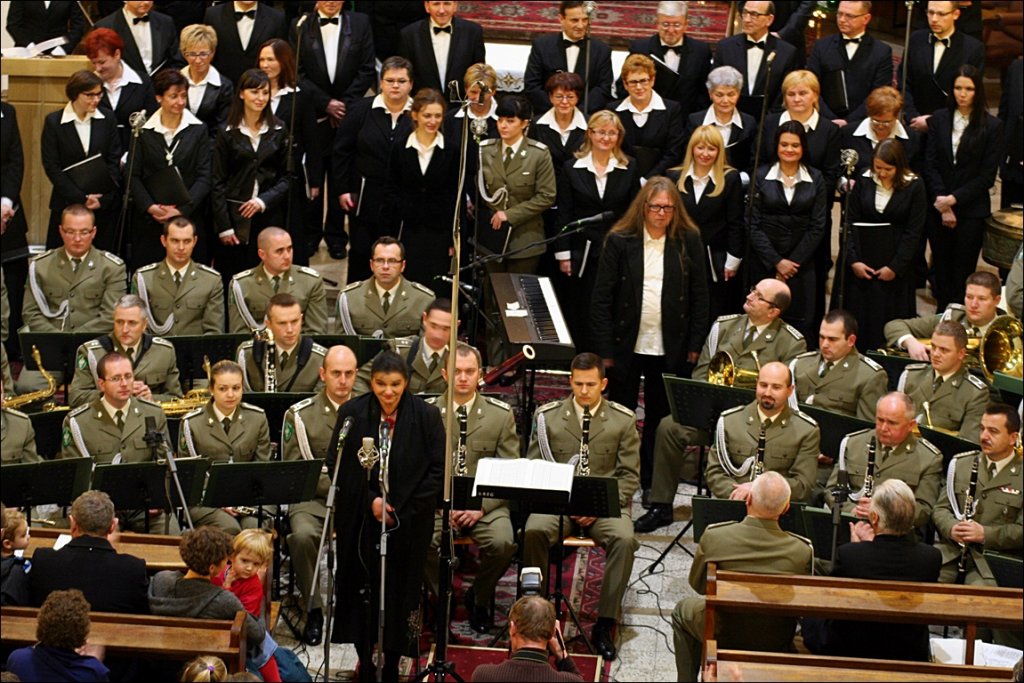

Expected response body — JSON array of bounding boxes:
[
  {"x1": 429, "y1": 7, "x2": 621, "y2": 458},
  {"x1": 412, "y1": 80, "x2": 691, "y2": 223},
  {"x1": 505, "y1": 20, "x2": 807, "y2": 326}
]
[{"x1": 897, "y1": 2, "x2": 985, "y2": 133}]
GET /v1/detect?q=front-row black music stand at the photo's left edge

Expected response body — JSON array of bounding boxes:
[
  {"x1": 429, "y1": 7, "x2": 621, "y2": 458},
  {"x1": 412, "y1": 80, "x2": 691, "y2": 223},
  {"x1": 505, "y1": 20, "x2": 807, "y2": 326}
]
[{"x1": 0, "y1": 458, "x2": 92, "y2": 526}]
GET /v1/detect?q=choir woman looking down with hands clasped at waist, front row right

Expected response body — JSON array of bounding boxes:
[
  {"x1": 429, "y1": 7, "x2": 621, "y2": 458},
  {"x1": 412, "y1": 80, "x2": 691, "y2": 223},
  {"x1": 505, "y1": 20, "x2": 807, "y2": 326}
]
[{"x1": 843, "y1": 138, "x2": 928, "y2": 349}]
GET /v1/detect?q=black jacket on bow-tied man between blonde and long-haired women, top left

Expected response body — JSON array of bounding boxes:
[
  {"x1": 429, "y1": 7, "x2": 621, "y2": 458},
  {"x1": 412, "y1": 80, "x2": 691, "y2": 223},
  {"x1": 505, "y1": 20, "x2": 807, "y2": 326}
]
[{"x1": 204, "y1": 2, "x2": 288, "y2": 83}]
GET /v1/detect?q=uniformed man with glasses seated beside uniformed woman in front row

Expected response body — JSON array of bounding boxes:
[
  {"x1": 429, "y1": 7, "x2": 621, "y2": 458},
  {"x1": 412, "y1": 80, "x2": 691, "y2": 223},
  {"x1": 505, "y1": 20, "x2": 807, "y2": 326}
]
[{"x1": 60, "y1": 351, "x2": 178, "y2": 533}]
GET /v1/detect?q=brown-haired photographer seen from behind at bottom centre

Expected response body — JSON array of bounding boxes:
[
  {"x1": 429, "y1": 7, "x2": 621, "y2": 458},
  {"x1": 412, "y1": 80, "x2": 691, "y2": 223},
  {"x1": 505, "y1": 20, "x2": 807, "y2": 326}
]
[{"x1": 472, "y1": 595, "x2": 583, "y2": 683}]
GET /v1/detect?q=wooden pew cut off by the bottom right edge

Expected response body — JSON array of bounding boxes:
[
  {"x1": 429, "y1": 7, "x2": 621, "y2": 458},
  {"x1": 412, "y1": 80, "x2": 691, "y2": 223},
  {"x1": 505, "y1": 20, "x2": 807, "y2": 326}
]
[{"x1": 707, "y1": 640, "x2": 1013, "y2": 683}]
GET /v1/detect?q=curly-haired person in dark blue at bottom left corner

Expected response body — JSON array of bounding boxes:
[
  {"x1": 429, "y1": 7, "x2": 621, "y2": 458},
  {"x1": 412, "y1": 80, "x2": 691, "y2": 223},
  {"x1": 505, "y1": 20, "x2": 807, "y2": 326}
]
[{"x1": 7, "y1": 589, "x2": 111, "y2": 681}]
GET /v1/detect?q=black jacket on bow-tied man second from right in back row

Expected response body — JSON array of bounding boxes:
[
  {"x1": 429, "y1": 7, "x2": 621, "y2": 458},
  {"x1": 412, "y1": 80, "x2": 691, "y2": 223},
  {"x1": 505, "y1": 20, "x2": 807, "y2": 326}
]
[{"x1": 807, "y1": 33, "x2": 893, "y2": 121}]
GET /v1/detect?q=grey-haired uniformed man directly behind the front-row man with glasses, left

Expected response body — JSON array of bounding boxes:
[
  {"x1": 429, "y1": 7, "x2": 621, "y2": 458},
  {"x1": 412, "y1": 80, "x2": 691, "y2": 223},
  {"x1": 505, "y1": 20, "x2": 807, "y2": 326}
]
[{"x1": 69, "y1": 294, "x2": 181, "y2": 407}]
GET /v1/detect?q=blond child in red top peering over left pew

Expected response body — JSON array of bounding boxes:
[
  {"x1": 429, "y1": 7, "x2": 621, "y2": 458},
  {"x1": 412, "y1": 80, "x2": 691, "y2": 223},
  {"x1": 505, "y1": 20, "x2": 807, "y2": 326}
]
[{"x1": 211, "y1": 528, "x2": 281, "y2": 682}]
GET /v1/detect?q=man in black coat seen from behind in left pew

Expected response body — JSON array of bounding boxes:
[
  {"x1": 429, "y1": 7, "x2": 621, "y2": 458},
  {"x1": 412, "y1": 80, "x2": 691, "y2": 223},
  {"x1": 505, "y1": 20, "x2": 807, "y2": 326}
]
[{"x1": 29, "y1": 490, "x2": 150, "y2": 614}]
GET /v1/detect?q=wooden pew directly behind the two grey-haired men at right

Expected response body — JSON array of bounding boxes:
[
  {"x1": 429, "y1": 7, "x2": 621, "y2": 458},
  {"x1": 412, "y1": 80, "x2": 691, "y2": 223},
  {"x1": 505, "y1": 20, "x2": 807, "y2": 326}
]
[{"x1": 705, "y1": 562, "x2": 1024, "y2": 664}]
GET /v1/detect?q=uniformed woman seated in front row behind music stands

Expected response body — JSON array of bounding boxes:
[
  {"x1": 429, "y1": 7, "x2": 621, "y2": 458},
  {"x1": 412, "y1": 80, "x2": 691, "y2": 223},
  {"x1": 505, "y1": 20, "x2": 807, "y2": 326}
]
[{"x1": 178, "y1": 360, "x2": 273, "y2": 536}]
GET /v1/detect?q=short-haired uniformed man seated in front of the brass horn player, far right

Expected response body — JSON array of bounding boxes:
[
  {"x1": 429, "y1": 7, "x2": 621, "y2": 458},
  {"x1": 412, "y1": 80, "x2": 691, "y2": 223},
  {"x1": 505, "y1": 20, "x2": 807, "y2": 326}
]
[{"x1": 897, "y1": 321, "x2": 989, "y2": 443}]
